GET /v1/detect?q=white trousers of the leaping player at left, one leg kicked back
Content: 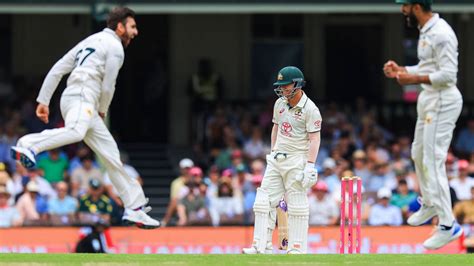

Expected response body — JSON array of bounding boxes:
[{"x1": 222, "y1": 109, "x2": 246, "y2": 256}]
[{"x1": 17, "y1": 95, "x2": 147, "y2": 209}]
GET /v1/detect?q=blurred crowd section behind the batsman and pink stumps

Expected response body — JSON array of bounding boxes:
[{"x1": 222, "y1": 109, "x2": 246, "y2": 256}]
[{"x1": 164, "y1": 99, "x2": 474, "y2": 230}]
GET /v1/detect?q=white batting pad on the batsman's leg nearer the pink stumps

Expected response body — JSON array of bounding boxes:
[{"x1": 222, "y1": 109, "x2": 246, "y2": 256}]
[{"x1": 288, "y1": 192, "x2": 309, "y2": 254}]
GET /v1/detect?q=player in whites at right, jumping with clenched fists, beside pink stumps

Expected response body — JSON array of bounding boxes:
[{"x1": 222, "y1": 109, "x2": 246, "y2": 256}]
[{"x1": 384, "y1": 0, "x2": 463, "y2": 249}]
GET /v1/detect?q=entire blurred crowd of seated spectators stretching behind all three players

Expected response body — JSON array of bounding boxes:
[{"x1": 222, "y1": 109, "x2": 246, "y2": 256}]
[{"x1": 0, "y1": 70, "x2": 474, "y2": 233}]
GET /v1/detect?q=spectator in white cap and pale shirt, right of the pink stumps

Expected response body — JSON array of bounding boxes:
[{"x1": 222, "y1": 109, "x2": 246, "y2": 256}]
[{"x1": 369, "y1": 188, "x2": 403, "y2": 226}]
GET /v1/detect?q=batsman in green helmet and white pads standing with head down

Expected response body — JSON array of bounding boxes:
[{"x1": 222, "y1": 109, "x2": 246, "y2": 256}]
[{"x1": 242, "y1": 66, "x2": 322, "y2": 254}]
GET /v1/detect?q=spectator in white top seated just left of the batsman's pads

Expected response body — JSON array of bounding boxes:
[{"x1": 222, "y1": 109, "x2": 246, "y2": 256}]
[{"x1": 209, "y1": 182, "x2": 244, "y2": 226}]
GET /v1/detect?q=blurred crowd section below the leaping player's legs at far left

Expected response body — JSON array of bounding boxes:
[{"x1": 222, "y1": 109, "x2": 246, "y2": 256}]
[{"x1": 0, "y1": 144, "x2": 141, "y2": 227}]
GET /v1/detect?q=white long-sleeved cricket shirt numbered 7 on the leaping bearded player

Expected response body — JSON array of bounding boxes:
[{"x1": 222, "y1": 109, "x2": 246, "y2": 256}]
[{"x1": 36, "y1": 28, "x2": 124, "y2": 113}]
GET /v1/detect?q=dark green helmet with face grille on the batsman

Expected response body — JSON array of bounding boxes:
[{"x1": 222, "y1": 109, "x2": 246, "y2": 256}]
[{"x1": 273, "y1": 66, "x2": 306, "y2": 99}]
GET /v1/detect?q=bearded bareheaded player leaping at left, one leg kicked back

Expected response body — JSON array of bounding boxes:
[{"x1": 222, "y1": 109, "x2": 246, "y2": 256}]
[{"x1": 11, "y1": 7, "x2": 160, "y2": 229}]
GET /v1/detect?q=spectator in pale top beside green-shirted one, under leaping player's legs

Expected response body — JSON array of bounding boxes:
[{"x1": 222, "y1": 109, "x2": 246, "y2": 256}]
[{"x1": 71, "y1": 153, "x2": 104, "y2": 197}]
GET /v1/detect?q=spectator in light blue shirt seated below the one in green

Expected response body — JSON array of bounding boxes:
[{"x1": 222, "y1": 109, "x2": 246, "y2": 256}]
[{"x1": 48, "y1": 181, "x2": 78, "y2": 225}]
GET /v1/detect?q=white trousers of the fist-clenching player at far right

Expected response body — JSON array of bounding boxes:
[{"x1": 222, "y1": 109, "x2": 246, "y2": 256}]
[{"x1": 412, "y1": 87, "x2": 463, "y2": 226}]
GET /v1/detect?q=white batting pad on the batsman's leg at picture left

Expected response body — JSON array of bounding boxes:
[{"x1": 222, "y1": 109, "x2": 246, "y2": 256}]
[{"x1": 252, "y1": 188, "x2": 270, "y2": 253}]
